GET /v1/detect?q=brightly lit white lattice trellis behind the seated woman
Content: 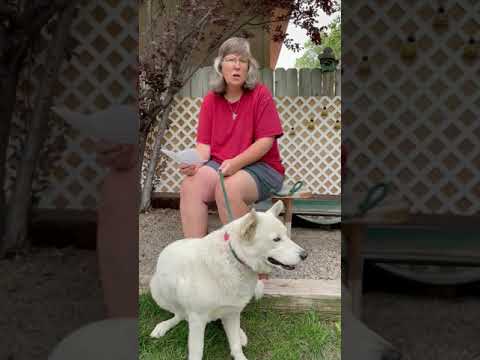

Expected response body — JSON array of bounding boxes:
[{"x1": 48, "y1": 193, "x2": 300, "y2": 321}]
[{"x1": 154, "y1": 97, "x2": 341, "y2": 194}]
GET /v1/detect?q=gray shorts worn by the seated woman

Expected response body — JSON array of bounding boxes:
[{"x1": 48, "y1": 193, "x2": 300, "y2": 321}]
[{"x1": 205, "y1": 160, "x2": 284, "y2": 201}]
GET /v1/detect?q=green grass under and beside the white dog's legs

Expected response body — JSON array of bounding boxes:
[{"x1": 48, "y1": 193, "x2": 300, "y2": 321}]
[{"x1": 139, "y1": 294, "x2": 341, "y2": 360}]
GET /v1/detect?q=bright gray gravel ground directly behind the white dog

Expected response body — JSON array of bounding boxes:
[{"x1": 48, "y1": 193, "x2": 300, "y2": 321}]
[{"x1": 139, "y1": 209, "x2": 341, "y2": 290}]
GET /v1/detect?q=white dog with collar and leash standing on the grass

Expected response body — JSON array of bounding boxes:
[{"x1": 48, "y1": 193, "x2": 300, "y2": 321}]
[{"x1": 150, "y1": 201, "x2": 307, "y2": 360}]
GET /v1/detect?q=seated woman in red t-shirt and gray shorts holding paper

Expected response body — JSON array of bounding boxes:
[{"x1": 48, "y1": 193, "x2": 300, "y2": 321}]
[{"x1": 180, "y1": 38, "x2": 285, "y2": 238}]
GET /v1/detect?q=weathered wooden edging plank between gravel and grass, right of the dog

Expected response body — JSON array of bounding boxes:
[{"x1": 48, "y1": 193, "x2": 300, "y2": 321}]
[{"x1": 251, "y1": 279, "x2": 341, "y2": 320}]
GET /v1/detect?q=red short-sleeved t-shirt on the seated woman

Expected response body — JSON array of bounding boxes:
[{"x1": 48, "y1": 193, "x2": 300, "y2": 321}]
[{"x1": 197, "y1": 84, "x2": 285, "y2": 175}]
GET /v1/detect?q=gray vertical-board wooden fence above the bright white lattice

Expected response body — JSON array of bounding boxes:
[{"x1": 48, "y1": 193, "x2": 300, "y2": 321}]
[{"x1": 179, "y1": 66, "x2": 341, "y2": 97}]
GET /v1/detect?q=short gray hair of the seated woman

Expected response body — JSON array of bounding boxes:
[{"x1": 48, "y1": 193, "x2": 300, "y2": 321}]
[{"x1": 210, "y1": 37, "x2": 258, "y2": 94}]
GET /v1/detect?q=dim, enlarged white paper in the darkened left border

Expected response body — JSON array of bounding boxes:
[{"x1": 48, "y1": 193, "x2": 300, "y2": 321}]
[{"x1": 52, "y1": 105, "x2": 139, "y2": 144}]
